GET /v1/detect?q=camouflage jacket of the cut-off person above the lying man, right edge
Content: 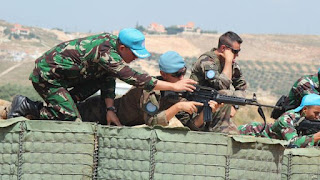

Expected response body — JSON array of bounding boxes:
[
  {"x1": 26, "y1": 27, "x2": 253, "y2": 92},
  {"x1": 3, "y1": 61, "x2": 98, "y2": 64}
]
[{"x1": 288, "y1": 74, "x2": 319, "y2": 107}]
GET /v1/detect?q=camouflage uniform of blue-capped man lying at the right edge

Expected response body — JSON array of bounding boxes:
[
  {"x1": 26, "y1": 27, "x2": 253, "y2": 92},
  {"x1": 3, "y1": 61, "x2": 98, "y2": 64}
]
[{"x1": 238, "y1": 110, "x2": 318, "y2": 147}]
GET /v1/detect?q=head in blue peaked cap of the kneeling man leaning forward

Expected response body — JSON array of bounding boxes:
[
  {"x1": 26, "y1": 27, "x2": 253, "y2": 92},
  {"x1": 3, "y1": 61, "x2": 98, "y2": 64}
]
[{"x1": 117, "y1": 28, "x2": 150, "y2": 63}]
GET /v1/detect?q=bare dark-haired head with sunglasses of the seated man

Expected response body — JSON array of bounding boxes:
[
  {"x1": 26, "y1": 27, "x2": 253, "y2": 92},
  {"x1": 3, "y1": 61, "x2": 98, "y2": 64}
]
[{"x1": 218, "y1": 31, "x2": 242, "y2": 59}]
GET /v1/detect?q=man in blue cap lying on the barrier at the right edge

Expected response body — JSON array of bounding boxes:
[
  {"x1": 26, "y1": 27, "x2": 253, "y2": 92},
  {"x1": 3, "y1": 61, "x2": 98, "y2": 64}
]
[{"x1": 238, "y1": 94, "x2": 320, "y2": 147}]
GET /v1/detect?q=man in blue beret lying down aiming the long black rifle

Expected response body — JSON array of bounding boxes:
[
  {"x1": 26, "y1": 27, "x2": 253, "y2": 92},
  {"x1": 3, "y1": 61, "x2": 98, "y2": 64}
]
[{"x1": 78, "y1": 51, "x2": 225, "y2": 130}]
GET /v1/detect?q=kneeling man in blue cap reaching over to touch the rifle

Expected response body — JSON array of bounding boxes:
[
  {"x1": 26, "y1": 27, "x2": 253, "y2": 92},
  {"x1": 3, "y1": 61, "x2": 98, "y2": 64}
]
[{"x1": 8, "y1": 28, "x2": 196, "y2": 125}]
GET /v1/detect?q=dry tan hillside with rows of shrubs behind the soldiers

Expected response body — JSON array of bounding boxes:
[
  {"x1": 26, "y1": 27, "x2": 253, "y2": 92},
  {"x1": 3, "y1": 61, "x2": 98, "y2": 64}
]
[{"x1": 0, "y1": 21, "x2": 320, "y2": 99}]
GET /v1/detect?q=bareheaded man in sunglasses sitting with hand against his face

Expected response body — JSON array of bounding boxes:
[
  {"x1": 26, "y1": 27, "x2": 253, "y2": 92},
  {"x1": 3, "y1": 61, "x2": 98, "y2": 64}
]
[{"x1": 190, "y1": 31, "x2": 247, "y2": 132}]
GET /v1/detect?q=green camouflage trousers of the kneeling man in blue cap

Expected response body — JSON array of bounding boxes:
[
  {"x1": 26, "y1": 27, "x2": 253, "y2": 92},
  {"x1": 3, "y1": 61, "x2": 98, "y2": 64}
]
[{"x1": 32, "y1": 80, "x2": 100, "y2": 121}]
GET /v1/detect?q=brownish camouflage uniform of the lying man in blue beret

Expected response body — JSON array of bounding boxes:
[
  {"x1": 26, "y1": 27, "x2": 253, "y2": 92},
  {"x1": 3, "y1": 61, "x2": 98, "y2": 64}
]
[{"x1": 77, "y1": 81, "x2": 179, "y2": 126}]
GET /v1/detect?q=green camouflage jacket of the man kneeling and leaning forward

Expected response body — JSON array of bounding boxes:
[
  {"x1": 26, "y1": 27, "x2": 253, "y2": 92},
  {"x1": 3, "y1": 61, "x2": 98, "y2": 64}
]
[{"x1": 29, "y1": 33, "x2": 156, "y2": 98}]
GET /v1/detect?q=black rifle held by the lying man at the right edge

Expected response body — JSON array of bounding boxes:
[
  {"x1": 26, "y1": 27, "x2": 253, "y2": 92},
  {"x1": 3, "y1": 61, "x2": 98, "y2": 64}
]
[{"x1": 294, "y1": 117, "x2": 320, "y2": 136}]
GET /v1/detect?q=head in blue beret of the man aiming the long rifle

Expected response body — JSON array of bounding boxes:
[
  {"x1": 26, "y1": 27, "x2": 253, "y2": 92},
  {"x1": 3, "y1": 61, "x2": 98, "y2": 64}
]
[{"x1": 159, "y1": 51, "x2": 187, "y2": 83}]
